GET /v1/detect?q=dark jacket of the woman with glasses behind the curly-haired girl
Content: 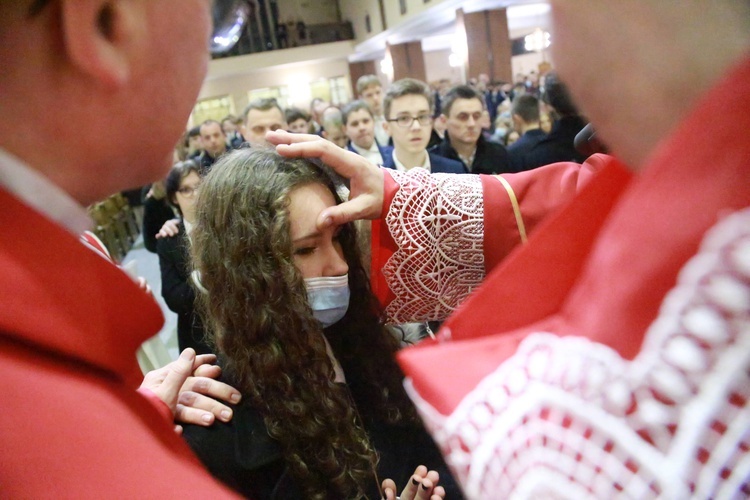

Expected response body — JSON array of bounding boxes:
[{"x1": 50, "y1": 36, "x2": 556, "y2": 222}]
[{"x1": 156, "y1": 223, "x2": 213, "y2": 354}]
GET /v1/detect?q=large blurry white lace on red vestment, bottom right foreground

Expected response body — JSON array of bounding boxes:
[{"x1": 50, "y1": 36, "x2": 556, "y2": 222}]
[{"x1": 407, "y1": 209, "x2": 750, "y2": 499}]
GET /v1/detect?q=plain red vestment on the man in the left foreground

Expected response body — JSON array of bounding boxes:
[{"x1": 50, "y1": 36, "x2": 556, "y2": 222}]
[{"x1": 0, "y1": 189, "x2": 238, "y2": 498}]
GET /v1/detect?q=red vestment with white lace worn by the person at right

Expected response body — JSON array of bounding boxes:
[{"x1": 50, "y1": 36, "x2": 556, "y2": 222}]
[{"x1": 376, "y1": 57, "x2": 750, "y2": 498}]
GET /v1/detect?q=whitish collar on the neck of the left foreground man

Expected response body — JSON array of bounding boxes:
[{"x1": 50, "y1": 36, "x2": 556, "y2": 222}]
[{"x1": 0, "y1": 148, "x2": 92, "y2": 236}]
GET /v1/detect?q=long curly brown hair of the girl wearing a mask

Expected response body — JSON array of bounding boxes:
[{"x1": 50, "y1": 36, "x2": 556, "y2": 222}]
[{"x1": 191, "y1": 149, "x2": 416, "y2": 498}]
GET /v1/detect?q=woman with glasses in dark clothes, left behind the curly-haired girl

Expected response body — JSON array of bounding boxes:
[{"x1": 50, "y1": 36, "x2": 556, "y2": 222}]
[{"x1": 156, "y1": 160, "x2": 213, "y2": 354}]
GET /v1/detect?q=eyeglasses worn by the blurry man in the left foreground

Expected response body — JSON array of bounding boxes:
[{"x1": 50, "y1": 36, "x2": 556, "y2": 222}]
[{"x1": 29, "y1": 0, "x2": 250, "y2": 55}]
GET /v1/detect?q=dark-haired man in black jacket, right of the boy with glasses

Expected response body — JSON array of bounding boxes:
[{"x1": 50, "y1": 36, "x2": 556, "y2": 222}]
[{"x1": 430, "y1": 85, "x2": 512, "y2": 174}]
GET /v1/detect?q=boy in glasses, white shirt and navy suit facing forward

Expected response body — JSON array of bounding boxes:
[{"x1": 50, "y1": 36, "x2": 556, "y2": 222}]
[{"x1": 383, "y1": 78, "x2": 466, "y2": 174}]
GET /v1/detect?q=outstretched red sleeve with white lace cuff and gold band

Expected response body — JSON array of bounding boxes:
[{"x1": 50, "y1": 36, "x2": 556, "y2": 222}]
[{"x1": 372, "y1": 155, "x2": 605, "y2": 323}]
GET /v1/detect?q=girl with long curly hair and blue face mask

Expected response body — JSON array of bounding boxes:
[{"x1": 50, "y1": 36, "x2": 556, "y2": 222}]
[{"x1": 184, "y1": 149, "x2": 461, "y2": 499}]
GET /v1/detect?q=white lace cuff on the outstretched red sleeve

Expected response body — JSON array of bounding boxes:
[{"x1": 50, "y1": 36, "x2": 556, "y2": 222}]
[{"x1": 383, "y1": 168, "x2": 484, "y2": 323}]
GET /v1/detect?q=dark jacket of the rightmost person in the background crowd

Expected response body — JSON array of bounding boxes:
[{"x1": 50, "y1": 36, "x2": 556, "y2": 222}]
[{"x1": 524, "y1": 116, "x2": 586, "y2": 170}]
